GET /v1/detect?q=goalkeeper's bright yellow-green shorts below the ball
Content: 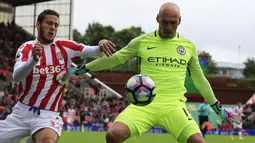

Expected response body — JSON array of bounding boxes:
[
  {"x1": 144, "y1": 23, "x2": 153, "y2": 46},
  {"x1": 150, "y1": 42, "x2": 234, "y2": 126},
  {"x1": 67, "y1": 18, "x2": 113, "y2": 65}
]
[{"x1": 114, "y1": 100, "x2": 201, "y2": 143}]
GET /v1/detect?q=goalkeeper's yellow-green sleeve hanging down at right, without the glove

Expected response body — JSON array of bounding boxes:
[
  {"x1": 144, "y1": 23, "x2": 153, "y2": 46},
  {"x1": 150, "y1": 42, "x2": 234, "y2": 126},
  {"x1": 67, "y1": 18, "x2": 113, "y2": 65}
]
[{"x1": 188, "y1": 44, "x2": 217, "y2": 105}]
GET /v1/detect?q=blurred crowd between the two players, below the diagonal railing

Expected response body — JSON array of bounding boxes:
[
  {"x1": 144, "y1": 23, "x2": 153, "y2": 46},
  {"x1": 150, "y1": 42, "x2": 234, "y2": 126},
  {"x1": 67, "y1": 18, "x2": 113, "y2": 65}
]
[{"x1": 61, "y1": 76, "x2": 128, "y2": 131}]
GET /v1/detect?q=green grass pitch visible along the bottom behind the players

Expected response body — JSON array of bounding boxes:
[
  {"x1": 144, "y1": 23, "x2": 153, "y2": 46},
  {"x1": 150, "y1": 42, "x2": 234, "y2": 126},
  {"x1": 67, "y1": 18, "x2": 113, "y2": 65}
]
[{"x1": 21, "y1": 132, "x2": 255, "y2": 143}]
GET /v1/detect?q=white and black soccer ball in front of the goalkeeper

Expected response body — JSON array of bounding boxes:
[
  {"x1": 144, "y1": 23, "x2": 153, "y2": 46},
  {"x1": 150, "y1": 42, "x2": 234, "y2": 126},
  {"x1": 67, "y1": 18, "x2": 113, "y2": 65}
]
[{"x1": 125, "y1": 74, "x2": 156, "y2": 106}]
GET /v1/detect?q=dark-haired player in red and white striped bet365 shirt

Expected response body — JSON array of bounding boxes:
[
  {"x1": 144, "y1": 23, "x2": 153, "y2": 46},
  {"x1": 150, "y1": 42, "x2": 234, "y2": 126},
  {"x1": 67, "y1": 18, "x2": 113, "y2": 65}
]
[{"x1": 0, "y1": 9, "x2": 115, "y2": 143}]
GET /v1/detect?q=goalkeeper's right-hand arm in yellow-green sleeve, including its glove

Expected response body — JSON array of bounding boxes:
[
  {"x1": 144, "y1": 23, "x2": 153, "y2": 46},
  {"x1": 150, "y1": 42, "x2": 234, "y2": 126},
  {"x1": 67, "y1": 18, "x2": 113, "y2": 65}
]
[{"x1": 189, "y1": 43, "x2": 241, "y2": 124}]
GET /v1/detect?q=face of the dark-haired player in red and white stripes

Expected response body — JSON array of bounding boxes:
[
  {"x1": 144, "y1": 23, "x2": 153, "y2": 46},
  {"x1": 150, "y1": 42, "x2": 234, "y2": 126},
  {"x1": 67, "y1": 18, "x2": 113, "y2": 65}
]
[{"x1": 37, "y1": 15, "x2": 59, "y2": 43}]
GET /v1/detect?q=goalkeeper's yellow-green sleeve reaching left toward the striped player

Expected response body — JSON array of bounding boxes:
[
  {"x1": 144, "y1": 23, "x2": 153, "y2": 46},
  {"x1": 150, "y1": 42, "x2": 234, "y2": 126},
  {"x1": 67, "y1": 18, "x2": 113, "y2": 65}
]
[{"x1": 86, "y1": 39, "x2": 139, "y2": 71}]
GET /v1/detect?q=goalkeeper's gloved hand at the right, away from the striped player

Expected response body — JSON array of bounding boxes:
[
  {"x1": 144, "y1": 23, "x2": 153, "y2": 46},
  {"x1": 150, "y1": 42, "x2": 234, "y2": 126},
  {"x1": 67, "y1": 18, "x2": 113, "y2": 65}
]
[{"x1": 211, "y1": 101, "x2": 241, "y2": 125}]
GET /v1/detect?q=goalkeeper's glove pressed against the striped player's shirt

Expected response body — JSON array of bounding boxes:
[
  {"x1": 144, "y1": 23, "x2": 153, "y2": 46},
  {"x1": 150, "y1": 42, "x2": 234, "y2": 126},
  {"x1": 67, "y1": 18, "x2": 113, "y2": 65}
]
[{"x1": 56, "y1": 64, "x2": 87, "y2": 86}]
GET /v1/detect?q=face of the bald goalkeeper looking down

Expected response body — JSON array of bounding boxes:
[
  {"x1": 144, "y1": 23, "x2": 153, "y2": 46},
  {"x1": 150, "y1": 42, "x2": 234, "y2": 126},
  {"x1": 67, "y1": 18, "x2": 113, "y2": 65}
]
[{"x1": 157, "y1": 12, "x2": 181, "y2": 39}]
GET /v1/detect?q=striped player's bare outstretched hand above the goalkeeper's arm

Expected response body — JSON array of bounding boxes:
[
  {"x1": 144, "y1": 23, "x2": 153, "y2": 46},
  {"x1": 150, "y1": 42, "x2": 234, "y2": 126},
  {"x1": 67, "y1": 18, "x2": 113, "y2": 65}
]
[{"x1": 98, "y1": 39, "x2": 116, "y2": 57}]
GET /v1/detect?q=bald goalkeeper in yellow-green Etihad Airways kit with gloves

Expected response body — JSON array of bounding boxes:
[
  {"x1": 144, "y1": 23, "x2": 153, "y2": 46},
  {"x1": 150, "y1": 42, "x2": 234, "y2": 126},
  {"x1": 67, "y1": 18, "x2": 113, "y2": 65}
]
[{"x1": 59, "y1": 3, "x2": 240, "y2": 143}]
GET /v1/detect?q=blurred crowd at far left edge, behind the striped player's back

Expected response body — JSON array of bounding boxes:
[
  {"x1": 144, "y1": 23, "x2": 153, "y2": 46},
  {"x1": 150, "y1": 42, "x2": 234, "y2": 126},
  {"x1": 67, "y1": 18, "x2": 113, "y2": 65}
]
[{"x1": 0, "y1": 21, "x2": 29, "y2": 119}]
